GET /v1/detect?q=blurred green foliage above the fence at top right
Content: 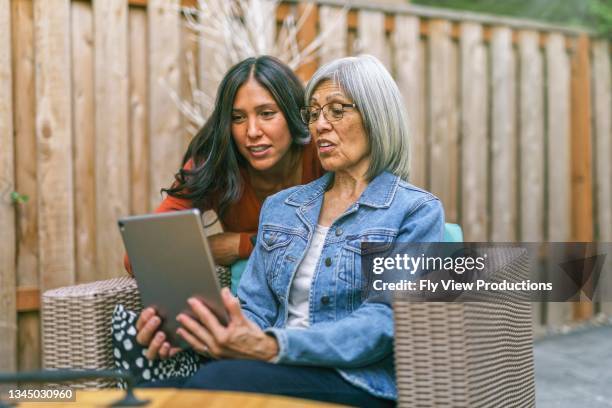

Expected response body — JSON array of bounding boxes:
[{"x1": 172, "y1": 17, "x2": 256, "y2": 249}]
[{"x1": 410, "y1": 0, "x2": 612, "y2": 38}]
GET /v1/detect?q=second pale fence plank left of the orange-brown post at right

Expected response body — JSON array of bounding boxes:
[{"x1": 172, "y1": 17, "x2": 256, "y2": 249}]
[{"x1": 519, "y1": 31, "x2": 545, "y2": 242}]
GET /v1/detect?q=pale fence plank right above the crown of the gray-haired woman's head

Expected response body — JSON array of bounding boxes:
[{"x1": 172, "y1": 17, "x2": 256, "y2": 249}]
[{"x1": 357, "y1": 10, "x2": 391, "y2": 68}]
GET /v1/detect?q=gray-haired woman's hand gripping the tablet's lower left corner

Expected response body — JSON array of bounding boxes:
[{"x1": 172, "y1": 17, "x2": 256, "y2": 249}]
[{"x1": 136, "y1": 307, "x2": 181, "y2": 360}]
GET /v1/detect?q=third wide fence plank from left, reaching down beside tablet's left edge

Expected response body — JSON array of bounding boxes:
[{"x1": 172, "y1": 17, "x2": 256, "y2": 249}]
[{"x1": 94, "y1": 0, "x2": 130, "y2": 279}]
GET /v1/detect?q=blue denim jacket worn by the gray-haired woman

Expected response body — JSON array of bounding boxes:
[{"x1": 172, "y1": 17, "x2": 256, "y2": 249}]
[{"x1": 238, "y1": 173, "x2": 444, "y2": 399}]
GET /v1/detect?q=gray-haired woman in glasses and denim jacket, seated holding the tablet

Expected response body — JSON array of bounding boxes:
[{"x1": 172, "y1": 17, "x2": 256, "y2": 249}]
[{"x1": 138, "y1": 55, "x2": 444, "y2": 407}]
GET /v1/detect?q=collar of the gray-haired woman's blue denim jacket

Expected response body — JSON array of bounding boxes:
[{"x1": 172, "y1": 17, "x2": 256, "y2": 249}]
[{"x1": 285, "y1": 172, "x2": 400, "y2": 208}]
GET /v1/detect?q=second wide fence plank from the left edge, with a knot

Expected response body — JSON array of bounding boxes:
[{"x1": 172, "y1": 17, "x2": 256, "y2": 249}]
[{"x1": 34, "y1": 0, "x2": 75, "y2": 291}]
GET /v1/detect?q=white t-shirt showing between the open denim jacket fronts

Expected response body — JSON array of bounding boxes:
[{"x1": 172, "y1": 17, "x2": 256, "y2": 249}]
[{"x1": 287, "y1": 225, "x2": 329, "y2": 328}]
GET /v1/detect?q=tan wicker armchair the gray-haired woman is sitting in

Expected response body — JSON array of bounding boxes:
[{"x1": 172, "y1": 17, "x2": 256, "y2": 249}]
[{"x1": 42, "y1": 249, "x2": 535, "y2": 407}]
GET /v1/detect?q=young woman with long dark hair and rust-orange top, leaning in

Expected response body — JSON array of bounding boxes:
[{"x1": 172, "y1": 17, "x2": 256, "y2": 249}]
[{"x1": 126, "y1": 56, "x2": 323, "y2": 271}]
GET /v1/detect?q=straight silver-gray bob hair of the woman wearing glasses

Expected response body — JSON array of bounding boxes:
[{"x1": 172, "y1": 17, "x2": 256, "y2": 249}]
[{"x1": 306, "y1": 55, "x2": 410, "y2": 180}]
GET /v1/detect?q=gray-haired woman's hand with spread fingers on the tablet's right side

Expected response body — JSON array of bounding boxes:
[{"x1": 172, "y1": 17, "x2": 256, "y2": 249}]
[{"x1": 176, "y1": 288, "x2": 278, "y2": 361}]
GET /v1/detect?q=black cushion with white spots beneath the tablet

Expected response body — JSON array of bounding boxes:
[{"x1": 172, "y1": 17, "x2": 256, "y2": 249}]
[{"x1": 111, "y1": 305, "x2": 200, "y2": 388}]
